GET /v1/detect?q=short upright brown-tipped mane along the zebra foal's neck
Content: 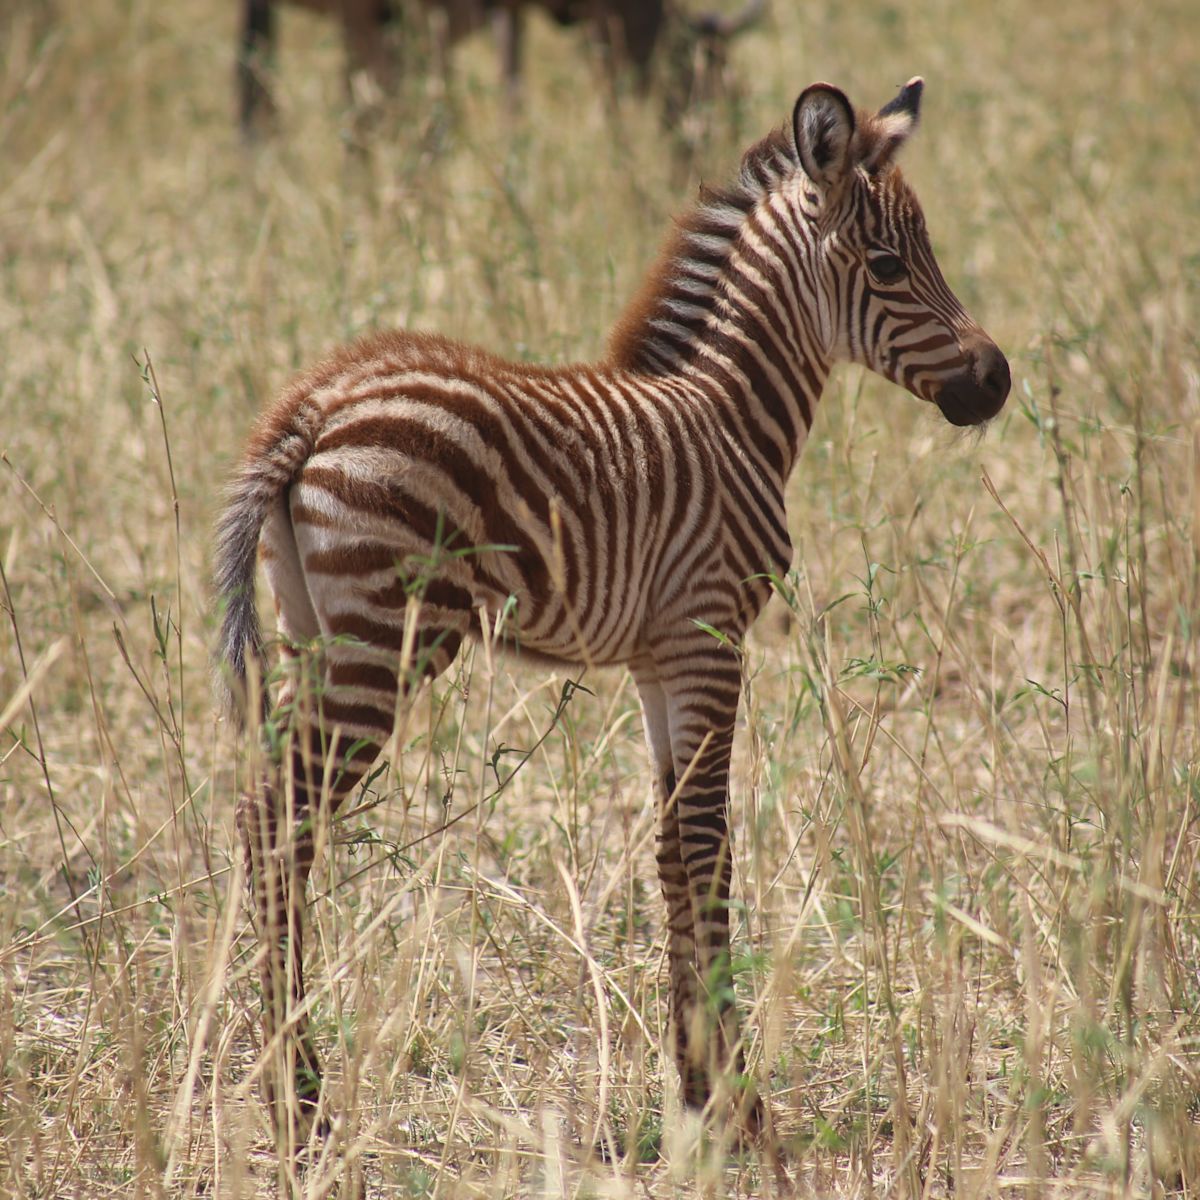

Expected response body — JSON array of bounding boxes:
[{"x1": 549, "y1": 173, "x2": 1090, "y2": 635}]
[{"x1": 608, "y1": 126, "x2": 799, "y2": 373}]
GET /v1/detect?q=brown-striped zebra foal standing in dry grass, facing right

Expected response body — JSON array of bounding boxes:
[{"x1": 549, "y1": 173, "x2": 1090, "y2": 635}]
[{"x1": 216, "y1": 78, "x2": 1009, "y2": 1148}]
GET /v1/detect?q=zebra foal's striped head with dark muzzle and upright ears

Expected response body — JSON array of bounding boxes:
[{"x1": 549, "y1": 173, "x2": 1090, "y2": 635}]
[{"x1": 792, "y1": 78, "x2": 1009, "y2": 425}]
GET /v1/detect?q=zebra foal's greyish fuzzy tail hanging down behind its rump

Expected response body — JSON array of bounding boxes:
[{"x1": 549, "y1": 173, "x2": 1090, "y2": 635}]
[{"x1": 214, "y1": 394, "x2": 319, "y2": 720}]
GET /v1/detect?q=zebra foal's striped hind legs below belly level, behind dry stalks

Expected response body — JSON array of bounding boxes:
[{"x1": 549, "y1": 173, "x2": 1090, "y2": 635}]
[{"x1": 238, "y1": 626, "x2": 461, "y2": 1163}]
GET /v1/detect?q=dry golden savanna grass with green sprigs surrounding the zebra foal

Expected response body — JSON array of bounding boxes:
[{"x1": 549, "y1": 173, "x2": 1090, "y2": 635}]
[{"x1": 0, "y1": 0, "x2": 1200, "y2": 1198}]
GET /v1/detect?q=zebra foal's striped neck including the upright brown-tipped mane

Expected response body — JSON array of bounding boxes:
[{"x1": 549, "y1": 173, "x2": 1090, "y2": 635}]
[{"x1": 608, "y1": 131, "x2": 829, "y2": 480}]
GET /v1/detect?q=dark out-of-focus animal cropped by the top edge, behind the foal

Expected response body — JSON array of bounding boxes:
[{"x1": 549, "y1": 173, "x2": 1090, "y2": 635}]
[{"x1": 238, "y1": 0, "x2": 767, "y2": 140}]
